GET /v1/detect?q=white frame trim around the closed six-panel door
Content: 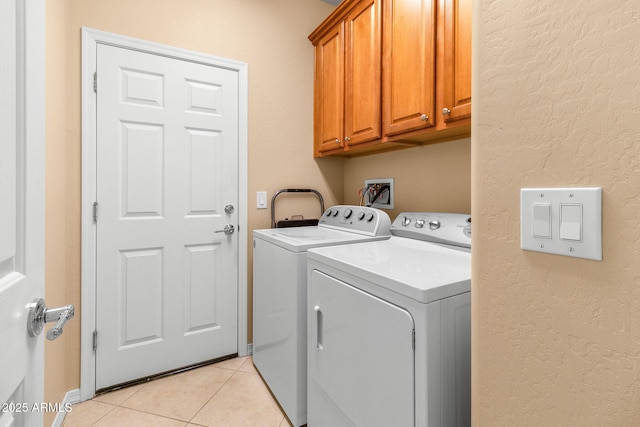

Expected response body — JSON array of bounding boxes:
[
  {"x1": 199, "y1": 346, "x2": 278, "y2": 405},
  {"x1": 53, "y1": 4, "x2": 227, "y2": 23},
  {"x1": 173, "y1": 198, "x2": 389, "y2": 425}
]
[{"x1": 80, "y1": 27, "x2": 248, "y2": 401}]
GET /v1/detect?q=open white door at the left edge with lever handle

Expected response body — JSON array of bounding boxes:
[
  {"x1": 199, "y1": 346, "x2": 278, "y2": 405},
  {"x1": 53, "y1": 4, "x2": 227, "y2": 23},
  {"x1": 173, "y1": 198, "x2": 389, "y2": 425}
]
[{"x1": 0, "y1": 0, "x2": 44, "y2": 427}]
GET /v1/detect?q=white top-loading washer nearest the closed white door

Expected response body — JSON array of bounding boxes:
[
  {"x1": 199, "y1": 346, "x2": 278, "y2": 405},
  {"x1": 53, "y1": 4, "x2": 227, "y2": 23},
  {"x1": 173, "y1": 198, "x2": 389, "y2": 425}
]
[{"x1": 253, "y1": 206, "x2": 391, "y2": 426}]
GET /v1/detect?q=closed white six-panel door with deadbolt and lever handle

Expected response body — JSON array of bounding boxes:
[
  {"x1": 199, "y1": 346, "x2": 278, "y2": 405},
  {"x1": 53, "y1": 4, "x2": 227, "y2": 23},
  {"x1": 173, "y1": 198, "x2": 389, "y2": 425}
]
[{"x1": 96, "y1": 44, "x2": 238, "y2": 389}]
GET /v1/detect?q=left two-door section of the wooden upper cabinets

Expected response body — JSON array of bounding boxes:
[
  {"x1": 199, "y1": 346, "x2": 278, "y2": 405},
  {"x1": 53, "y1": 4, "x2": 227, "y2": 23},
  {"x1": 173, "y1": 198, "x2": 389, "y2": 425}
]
[{"x1": 309, "y1": 0, "x2": 382, "y2": 156}]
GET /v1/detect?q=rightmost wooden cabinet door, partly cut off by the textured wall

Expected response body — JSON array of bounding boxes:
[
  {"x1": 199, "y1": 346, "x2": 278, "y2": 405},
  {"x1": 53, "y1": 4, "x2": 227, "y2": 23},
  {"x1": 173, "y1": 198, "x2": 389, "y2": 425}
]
[{"x1": 438, "y1": 0, "x2": 471, "y2": 124}]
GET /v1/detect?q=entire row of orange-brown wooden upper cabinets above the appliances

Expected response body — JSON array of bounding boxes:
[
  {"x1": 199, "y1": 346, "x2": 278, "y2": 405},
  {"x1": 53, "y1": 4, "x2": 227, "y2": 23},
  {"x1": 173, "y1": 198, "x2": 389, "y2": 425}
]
[{"x1": 309, "y1": 0, "x2": 472, "y2": 157}]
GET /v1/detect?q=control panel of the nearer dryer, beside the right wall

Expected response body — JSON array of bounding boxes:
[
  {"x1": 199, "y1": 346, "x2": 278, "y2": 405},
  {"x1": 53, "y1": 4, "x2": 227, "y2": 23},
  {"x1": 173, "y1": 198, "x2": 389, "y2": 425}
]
[{"x1": 391, "y1": 212, "x2": 471, "y2": 248}]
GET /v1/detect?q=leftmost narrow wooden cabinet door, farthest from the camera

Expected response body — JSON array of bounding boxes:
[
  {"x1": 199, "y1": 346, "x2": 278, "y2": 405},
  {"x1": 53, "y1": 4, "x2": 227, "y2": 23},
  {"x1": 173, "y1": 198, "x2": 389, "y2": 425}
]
[{"x1": 314, "y1": 22, "x2": 344, "y2": 156}]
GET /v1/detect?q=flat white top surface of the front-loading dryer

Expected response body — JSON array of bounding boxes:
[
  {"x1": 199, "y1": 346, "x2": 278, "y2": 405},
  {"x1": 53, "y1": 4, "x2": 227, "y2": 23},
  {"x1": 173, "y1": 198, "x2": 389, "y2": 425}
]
[{"x1": 307, "y1": 236, "x2": 471, "y2": 303}]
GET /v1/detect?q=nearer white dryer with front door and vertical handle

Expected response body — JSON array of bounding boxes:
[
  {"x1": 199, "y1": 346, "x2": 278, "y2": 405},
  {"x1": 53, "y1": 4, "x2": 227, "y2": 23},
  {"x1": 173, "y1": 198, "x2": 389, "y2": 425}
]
[{"x1": 307, "y1": 213, "x2": 471, "y2": 427}]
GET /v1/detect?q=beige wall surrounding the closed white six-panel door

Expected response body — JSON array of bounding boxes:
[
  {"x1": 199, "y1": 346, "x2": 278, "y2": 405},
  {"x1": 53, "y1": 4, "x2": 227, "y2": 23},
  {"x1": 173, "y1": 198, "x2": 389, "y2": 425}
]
[{"x1": 45, "y1": 0, "x2": 336, "y2": 414}]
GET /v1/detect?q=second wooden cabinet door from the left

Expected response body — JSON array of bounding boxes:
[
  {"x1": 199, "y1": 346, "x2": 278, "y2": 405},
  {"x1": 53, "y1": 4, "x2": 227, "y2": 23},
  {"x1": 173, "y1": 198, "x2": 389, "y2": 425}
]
[{"x1": 344, "y1": 0, "x2": 382, "y2": 145}]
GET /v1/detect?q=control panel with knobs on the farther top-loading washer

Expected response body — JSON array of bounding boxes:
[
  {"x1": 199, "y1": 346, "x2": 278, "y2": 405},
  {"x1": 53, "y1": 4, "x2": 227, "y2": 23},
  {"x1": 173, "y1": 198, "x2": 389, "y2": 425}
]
[{"x1": 318, "y1": 205, "x2": 391, "y2": 236}]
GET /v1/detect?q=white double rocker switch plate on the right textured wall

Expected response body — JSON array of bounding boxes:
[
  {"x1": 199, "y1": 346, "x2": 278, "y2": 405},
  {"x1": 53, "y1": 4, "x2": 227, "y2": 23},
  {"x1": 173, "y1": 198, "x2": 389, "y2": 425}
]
[{"x1": 520, "y1": 187, "x2": 602, "y2": 261}]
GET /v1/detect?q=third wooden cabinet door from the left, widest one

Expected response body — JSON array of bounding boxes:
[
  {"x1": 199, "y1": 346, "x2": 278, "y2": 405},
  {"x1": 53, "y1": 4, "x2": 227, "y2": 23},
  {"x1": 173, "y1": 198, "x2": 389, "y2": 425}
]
[{"x1": 382, "y1": 0, "x2": 436, "y2": 136}]
